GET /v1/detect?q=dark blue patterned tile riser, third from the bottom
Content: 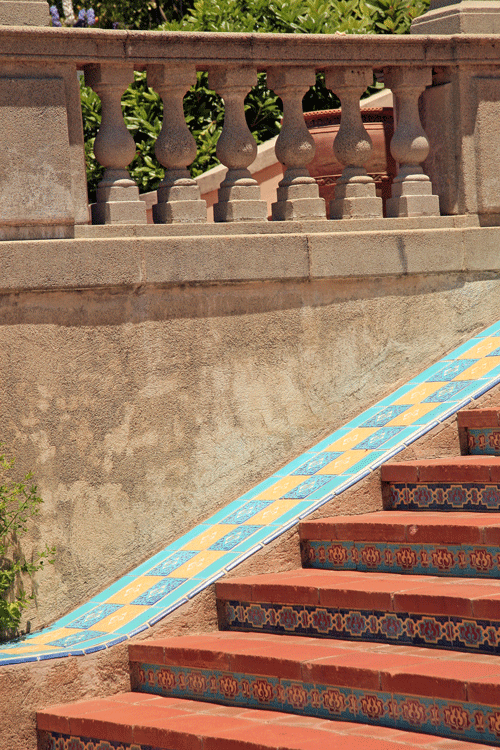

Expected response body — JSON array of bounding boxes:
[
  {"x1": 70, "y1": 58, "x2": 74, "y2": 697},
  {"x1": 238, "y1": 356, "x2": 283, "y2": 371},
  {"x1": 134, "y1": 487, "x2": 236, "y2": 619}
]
[{"x1": 220, "y1": 601, "x2": 500, "y2": 654}]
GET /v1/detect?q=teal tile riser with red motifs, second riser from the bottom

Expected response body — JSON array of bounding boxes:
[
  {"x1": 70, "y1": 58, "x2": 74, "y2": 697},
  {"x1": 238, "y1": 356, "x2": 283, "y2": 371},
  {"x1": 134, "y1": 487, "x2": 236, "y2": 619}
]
[{"x1": 134, "y1": 664, "x2": 500, "y2": 750}]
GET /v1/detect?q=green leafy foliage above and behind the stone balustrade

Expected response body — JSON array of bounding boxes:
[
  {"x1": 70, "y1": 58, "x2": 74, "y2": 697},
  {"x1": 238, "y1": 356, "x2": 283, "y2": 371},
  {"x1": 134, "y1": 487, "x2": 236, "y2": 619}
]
[{"x1": 77, "y1": 0, "x2": 428, "y2": 200}]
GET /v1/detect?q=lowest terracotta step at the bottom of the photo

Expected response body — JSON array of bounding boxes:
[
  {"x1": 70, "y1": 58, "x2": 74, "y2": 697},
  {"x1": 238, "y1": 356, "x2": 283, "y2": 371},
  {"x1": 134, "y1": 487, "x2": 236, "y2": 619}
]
[{"x1": 38, "y1": 693, "x2": 494, "y2": 750}]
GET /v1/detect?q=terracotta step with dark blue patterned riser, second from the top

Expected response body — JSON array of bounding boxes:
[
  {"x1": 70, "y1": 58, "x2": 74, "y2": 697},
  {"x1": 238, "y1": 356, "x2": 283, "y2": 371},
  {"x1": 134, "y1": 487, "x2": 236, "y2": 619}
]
[{"x1": 381, "y1": 456, "x2": 500, "y2": 512}]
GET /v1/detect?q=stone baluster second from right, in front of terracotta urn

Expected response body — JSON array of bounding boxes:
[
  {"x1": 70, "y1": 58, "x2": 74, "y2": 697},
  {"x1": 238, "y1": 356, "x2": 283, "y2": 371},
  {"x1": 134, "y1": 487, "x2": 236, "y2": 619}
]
[{"x1": 325, "y1": 68, "x2": 382, "y2": 219}]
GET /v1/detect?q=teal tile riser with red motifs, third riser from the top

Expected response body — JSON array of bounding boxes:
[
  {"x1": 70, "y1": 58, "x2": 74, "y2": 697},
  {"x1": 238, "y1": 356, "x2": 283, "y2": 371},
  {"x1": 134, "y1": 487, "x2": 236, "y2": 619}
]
[{"x1": 302, "y1": 539, "x2": 500, "y2": 578}]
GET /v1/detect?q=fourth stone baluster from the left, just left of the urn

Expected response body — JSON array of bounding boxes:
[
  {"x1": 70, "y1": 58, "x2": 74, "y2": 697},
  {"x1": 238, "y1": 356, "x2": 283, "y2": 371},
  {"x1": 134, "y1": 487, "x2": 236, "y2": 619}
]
[{"x1": 267, "y1": 67, "x2": 326, "y2": 221}]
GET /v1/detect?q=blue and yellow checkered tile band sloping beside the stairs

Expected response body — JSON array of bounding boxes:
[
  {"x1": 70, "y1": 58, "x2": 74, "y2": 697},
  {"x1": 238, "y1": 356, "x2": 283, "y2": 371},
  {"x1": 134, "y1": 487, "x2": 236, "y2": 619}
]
[{"x1": 4, "y1": 322, "x2": 500, "y2": 664}]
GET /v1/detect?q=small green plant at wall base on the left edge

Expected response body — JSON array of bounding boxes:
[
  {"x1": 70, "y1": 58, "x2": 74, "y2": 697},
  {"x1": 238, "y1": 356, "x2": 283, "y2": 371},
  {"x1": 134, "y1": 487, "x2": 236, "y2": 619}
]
[{"x1": 0, "y1": 444, "x2": 55, "y2": 642}]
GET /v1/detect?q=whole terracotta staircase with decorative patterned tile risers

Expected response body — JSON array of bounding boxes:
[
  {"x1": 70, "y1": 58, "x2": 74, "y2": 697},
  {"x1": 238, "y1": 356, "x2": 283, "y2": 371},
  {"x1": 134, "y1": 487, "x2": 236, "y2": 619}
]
[{"x1": 38, "y1": 410, "x2": 500, "y2": 750}]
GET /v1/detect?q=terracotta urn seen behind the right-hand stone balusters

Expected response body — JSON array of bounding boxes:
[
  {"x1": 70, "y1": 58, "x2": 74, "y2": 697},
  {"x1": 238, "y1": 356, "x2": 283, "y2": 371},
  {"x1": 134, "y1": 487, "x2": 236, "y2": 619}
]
[{"x1": 304, "y1": 107, "x2": 397, "y2": 218}]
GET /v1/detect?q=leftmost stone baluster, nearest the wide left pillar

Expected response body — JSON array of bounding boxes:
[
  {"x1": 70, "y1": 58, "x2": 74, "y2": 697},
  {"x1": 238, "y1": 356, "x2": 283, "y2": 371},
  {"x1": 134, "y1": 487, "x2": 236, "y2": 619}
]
[{"x1": 85, "y1": 64, "x2": 146, "y2": 224}]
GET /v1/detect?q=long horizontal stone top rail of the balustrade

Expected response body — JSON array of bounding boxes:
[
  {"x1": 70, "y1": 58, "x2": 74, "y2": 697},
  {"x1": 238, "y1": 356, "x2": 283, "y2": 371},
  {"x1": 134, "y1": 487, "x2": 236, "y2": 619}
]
[{"x1": 0, "y1": 26, "x2": 500, "y2": 71}]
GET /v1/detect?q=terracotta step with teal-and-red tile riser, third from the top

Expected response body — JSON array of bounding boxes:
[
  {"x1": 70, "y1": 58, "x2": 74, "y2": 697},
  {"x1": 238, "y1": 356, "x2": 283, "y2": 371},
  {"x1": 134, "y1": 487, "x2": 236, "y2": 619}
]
[{"x1": 300, "y1": 510, "x2": 500, "y2": 578}]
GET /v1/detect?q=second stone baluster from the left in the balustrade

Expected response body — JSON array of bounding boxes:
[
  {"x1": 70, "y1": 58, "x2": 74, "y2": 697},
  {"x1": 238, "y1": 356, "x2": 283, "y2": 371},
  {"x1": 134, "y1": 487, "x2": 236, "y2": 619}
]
[{"x1": 148, "y1": 64, "x2": 207, "y2": 224}]
